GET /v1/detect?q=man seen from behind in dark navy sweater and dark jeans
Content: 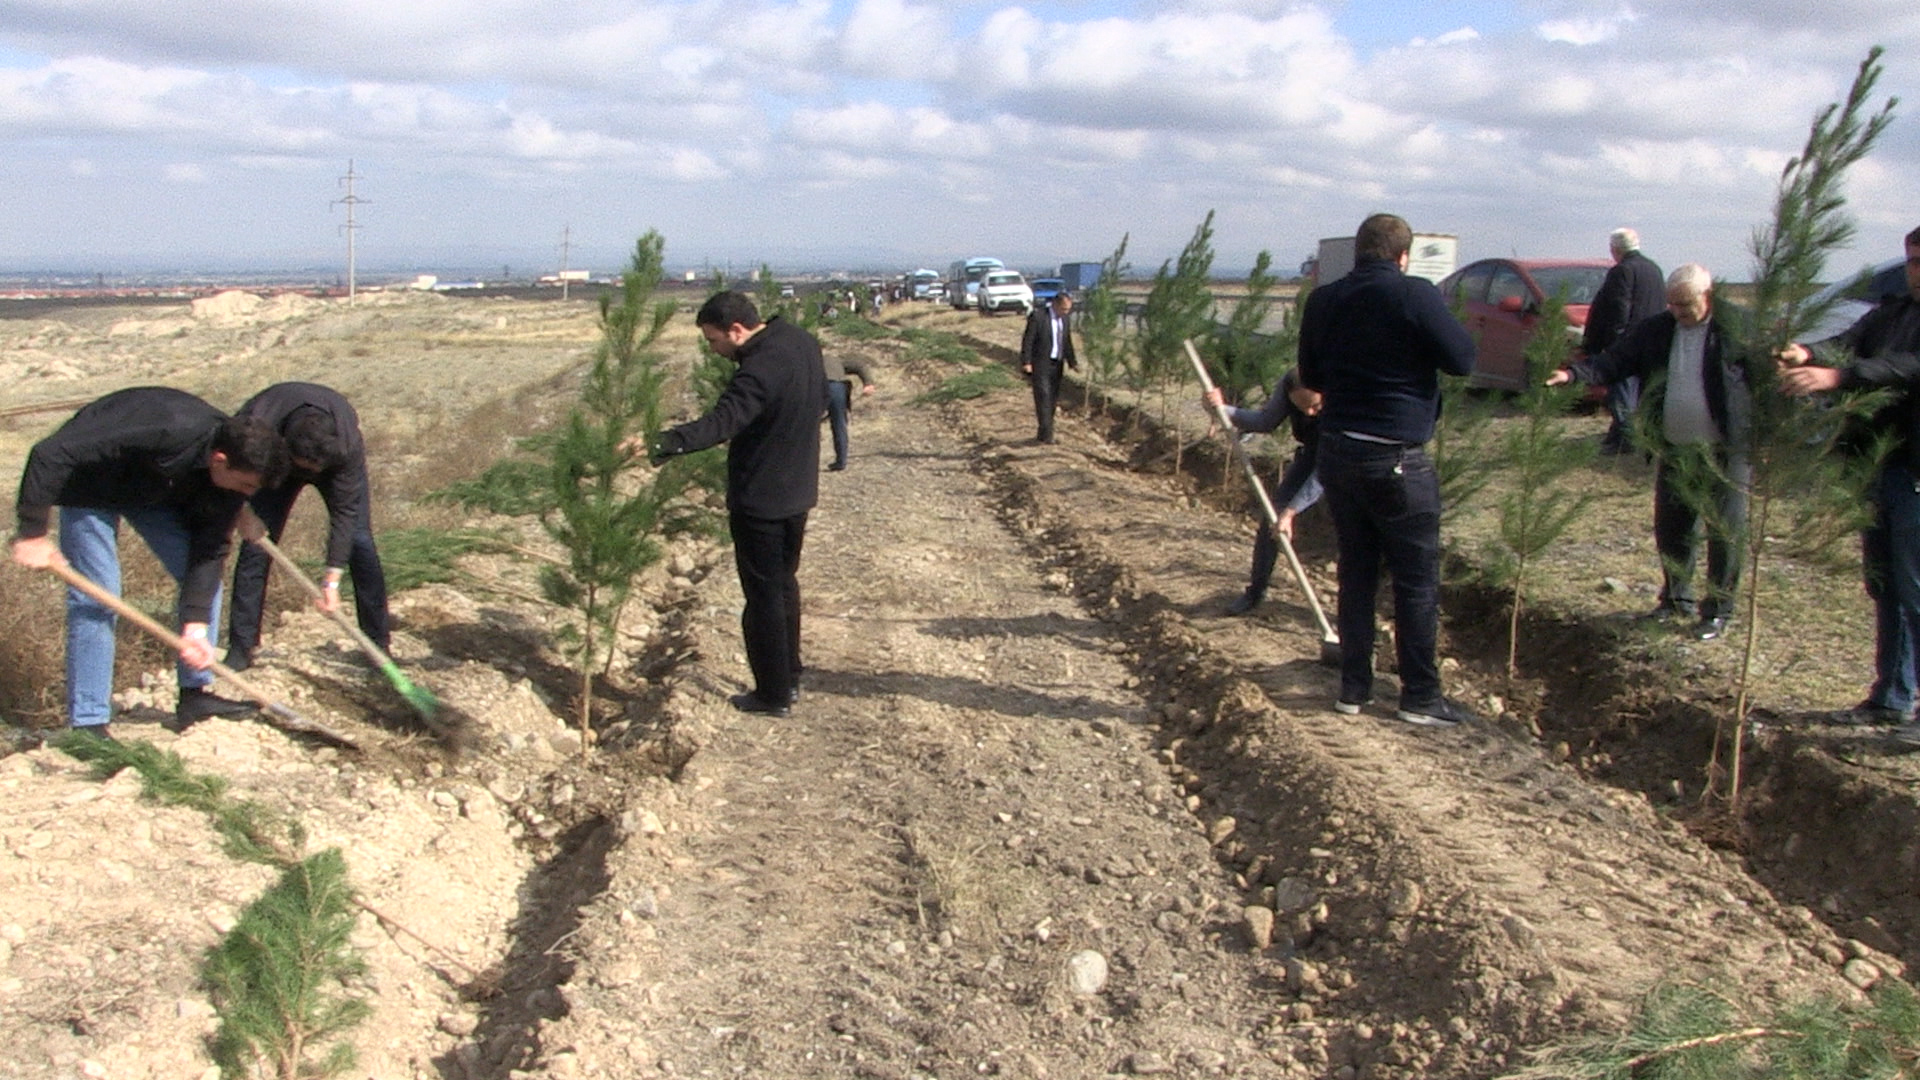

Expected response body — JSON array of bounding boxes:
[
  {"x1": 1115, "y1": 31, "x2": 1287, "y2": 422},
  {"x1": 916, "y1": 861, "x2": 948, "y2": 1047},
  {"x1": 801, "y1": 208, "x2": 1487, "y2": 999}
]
[{"x1": 1300, "y1": 213, "x2": 1473, "y2": 726}]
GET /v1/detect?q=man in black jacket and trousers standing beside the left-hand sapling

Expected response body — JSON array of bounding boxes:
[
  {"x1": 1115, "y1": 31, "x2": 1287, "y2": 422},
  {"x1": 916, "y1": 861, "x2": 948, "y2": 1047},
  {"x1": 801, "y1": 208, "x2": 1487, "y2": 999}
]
[{"x1": 651, "y1": 292, "x2": 828, "y2": 717}]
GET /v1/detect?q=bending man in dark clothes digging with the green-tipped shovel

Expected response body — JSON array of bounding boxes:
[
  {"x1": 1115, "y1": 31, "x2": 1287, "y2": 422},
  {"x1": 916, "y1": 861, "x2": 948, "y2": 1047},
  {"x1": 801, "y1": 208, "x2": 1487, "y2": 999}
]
[{"x1": 227, "y1": 382, "x2": 392, "y2": 671}]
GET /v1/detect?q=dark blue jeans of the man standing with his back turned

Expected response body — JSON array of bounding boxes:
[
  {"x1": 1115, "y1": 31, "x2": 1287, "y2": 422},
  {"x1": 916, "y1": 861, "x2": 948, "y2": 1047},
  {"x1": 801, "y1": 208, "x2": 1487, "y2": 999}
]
[{"x1": 1319, "y1": 430, "x2": 1440, "y2": 707}]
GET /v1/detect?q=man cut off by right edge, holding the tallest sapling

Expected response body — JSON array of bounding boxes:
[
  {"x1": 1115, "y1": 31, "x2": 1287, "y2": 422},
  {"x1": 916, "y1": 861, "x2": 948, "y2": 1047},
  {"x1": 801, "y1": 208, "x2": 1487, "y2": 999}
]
[{"x1": 1780, "y1": 229, "x2": 1920, "y2": 730}]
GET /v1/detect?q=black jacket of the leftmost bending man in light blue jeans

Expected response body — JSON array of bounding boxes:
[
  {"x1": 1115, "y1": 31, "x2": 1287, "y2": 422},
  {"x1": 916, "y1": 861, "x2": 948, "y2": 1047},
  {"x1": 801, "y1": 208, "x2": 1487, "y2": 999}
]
[{"x1": 15, "y1": 386, "x2": 244, "y2": 623}]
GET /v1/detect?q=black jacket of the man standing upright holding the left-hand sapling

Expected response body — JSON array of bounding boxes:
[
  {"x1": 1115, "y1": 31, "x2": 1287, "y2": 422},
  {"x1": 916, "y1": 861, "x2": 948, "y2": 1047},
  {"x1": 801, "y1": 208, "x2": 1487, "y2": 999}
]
[{"x1": 662, "y1": 315, "x2": 828, "y2": 521}]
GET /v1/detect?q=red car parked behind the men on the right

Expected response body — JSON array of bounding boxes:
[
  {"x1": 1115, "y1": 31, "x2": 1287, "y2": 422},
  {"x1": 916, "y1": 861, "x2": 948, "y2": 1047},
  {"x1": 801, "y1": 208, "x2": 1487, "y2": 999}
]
[{"x1": 1440, "y1": 259, "x2": 1613, "y2": 390}]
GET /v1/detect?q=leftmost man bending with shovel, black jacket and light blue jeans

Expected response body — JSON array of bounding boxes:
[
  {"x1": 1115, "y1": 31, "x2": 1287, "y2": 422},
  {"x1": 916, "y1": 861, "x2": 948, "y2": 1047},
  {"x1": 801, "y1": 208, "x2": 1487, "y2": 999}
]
[{"x1": 13, "y1": 386, "x2": 286, "y2": 738}]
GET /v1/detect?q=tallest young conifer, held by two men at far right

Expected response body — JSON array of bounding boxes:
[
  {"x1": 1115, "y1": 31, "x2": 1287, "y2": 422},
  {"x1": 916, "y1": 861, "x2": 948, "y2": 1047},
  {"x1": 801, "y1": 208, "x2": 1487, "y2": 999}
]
[{"x1": 1670, "y1": 48, "x2": 1899, "y2": 813}]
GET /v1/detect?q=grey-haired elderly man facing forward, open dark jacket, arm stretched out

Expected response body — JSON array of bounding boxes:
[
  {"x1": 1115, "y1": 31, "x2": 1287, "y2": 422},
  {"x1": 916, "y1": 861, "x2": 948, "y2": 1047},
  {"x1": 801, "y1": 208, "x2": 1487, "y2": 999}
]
[{"x1": 1548, "y1": 263, "x2": 1753, "y2": 642}]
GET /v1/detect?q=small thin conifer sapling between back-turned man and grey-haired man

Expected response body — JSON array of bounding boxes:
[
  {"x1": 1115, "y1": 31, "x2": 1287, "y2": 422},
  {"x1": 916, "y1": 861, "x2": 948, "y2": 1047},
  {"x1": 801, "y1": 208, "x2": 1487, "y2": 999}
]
[{"x1": 1488, "y1": 296, "x2": 1597, "y2": 680}]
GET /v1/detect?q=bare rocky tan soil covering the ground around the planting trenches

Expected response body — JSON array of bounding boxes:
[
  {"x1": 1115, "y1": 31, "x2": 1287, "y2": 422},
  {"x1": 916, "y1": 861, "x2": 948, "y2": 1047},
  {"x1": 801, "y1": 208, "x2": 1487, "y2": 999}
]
[{"x1": 0, "y1": 296, "x2": 1914, "y2": 1080}]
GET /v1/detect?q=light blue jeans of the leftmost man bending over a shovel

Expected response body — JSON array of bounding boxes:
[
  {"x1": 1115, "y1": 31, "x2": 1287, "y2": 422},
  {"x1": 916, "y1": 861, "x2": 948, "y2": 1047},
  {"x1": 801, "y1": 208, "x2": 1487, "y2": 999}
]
[{"x1": 60, "y1": 505, "x2": 221, "y2": 728}]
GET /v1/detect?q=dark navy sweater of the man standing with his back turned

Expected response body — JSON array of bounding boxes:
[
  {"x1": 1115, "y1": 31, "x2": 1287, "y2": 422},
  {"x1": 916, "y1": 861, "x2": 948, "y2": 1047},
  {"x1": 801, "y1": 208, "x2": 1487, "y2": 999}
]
[{"x1": 1300, "y1": 259, "x2": 1473, "y2": 444}]
